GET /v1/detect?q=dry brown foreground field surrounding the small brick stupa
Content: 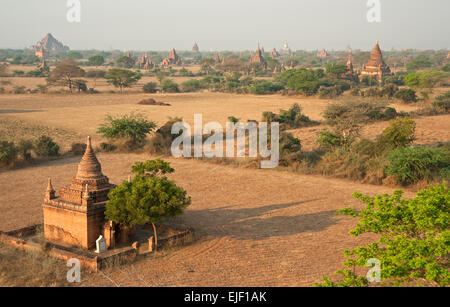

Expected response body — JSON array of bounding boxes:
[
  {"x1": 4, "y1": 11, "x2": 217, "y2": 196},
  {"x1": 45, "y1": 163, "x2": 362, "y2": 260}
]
[{"x1": 0, "y1": 154, "x2": 413, "y2": 286}]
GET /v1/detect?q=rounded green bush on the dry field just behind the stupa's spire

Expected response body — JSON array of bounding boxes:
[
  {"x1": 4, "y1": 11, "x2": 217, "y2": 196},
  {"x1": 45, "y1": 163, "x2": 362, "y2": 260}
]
[{"x1": 97, "y1": 113, "x2": 156, "y2": 145}]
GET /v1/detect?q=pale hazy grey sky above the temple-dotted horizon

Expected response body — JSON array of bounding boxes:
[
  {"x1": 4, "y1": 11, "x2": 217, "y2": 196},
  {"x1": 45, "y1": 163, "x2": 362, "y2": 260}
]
[{"x1": 0, "y1": 0, "x2": 450, "y2": 51}]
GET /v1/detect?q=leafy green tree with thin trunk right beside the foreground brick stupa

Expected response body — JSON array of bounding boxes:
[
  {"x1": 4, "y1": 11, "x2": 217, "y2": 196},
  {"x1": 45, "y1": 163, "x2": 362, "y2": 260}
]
[{"x1": 105, "y1": 159, "x2": 191, "y2": 247}]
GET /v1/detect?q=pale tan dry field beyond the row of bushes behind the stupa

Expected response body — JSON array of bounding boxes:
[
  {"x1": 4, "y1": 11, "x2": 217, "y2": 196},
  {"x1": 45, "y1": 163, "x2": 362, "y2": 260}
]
[{"x1": 0, "y1": 93, "x2": 329, "y2": 148}]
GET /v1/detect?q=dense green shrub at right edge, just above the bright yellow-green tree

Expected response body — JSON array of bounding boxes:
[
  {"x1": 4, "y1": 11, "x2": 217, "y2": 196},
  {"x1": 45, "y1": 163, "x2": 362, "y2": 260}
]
[{"x1": 386, "y1": 146, "x2": 450, "y2": 184}]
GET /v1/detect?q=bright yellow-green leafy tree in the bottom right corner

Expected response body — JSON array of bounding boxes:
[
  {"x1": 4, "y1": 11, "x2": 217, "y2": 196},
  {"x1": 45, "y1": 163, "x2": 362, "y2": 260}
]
[{"x1": 316, "y1": 183, "x2": 450, "y2": 287}]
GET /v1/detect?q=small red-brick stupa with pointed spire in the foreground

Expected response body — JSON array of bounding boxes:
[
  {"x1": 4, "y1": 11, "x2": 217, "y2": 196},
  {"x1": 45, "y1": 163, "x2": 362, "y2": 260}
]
[{"x1": 43, "y1": 137, "x2": 115, "y2": 248}]
